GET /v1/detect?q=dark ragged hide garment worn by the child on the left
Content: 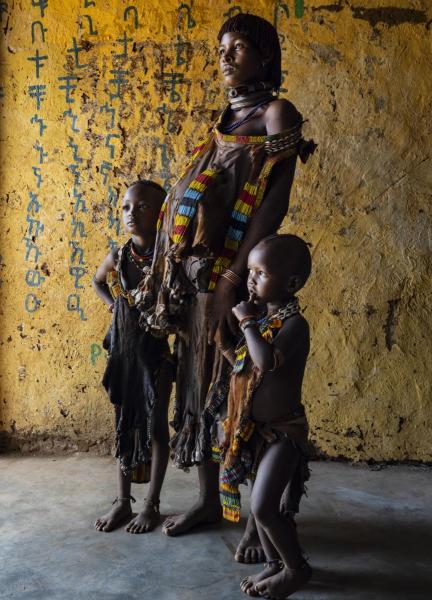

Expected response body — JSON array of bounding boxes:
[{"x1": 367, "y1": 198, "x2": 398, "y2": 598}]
[{"x1": 102, "y1": 296, "x2": 170, "y2": 472}]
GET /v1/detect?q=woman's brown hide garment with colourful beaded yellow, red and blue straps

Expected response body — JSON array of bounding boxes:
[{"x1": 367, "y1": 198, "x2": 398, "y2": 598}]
[{"x1": 140, "y1": 115, "x2": 314, "y2": 468}]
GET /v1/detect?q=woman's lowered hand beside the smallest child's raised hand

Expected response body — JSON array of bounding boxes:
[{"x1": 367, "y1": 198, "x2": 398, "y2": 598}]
[{"x1": 208, "y1": 277, "x2": 238, "y2": 344}]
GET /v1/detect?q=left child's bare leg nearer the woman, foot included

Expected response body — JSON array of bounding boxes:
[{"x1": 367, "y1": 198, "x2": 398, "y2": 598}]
[{"x1": 126, "y1": 365, "x2": 171, "y2": 533}]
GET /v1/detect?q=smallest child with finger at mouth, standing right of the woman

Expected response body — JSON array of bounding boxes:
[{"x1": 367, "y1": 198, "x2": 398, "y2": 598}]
[{"x1": 221, "y1": 235, "x2": 312, "y2": 598}]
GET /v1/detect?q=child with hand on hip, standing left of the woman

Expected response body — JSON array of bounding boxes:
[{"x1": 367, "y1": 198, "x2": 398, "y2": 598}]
[{"x1": 93, "y1": 181, "x2": 172, "y2": 533}]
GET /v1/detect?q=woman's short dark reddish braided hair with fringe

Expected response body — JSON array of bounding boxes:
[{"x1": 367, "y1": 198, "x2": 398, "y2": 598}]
[{"x1": 218, "y1": 13, "x2": 282, "y2": 90}]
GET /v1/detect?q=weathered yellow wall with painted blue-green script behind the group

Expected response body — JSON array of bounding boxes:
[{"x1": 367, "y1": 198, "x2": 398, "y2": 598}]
[{"x1": 0, "y1": 0, "x2": 432, "y2": 460}]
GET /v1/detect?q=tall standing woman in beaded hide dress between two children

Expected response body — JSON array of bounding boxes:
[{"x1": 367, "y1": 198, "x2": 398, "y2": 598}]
[{"x1": 142, "y1": 14, "x2": 314, "y2": 562}]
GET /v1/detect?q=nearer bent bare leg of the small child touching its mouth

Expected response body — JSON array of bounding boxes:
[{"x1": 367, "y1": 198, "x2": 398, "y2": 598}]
[{"x1": 251, "y1": 438, "x2": 311, "y2": 598}]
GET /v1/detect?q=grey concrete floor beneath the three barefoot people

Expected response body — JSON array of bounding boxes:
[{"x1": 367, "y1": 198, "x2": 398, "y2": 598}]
[{"x1": 0, "y1": 454, "x2": 432, "y2": 600}]
